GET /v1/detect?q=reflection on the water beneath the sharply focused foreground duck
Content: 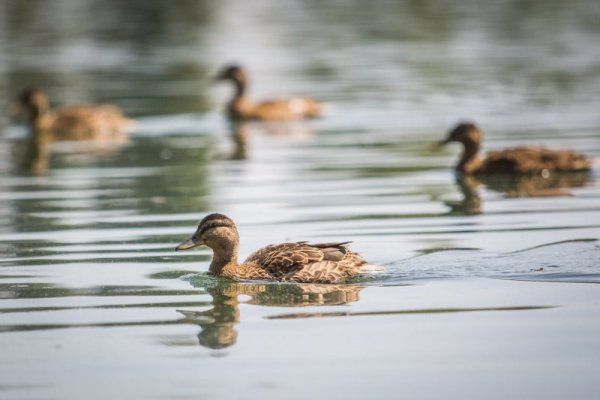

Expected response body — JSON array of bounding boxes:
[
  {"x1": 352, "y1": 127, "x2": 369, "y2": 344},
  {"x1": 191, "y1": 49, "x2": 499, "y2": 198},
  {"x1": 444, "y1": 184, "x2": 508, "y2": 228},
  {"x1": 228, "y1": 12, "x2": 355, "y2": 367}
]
[{"x1": 179, "y1": 281, "x2": 363, "y2": 349}]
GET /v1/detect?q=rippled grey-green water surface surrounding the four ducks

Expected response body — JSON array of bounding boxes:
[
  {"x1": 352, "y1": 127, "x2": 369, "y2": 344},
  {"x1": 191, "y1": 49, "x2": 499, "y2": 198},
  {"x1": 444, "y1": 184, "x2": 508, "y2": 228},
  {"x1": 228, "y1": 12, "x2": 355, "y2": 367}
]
[{"x1": 0, "y1": 0, "x2": 600, "y2": 399}]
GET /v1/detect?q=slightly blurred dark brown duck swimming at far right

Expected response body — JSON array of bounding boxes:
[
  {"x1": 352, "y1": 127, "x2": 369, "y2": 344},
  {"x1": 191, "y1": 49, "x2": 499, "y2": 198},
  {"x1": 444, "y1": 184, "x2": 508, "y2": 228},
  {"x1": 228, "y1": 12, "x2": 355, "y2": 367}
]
[{"x1": 439, "y1": 122, "x2": 592, "y2": 177}]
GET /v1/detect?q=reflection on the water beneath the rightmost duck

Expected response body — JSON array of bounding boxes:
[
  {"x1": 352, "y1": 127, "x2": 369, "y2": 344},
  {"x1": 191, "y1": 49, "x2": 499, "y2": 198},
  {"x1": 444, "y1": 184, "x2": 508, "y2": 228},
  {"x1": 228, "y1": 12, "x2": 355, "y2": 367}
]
[{"x1": 445, "y1": 171, "x2": 592, "y2": 215}]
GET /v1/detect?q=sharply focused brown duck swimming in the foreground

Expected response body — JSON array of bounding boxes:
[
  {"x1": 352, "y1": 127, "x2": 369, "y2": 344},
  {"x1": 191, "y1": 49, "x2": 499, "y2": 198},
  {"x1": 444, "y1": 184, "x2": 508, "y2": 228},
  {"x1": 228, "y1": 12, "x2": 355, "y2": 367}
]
[{"x1": 176, "y1": 213, "x2": 374, "y2": 283}]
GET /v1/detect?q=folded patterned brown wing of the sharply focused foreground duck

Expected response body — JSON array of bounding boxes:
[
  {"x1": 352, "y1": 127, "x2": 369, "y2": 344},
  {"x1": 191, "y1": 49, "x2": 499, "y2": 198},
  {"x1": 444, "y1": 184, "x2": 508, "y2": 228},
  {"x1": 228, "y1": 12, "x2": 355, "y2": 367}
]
[{"x1": 244, "y1": 242, "x2": 354, "y2": 278}]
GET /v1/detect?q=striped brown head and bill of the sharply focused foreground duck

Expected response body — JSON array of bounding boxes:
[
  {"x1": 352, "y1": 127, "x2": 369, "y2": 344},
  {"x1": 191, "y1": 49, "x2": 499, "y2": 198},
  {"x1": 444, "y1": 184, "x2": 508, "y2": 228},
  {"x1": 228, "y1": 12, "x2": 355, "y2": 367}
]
[{"x1": 175, "y1": 214, "x2": 239, "y2": 254}]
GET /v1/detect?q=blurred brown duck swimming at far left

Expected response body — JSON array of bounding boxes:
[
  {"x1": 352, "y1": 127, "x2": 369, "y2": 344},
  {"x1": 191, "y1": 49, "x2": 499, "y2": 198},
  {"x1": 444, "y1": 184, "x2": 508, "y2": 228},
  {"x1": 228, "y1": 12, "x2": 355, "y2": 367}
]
[{"x1": 13, "y1": 88, "x2": 134, "y2": 141}]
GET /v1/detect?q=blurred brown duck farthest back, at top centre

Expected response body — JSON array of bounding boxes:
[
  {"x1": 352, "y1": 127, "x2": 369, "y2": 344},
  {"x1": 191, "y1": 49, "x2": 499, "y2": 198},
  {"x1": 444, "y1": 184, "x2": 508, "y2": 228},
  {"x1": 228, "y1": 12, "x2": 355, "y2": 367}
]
[{"x1": 215, "y1": 64, "x2": 323, "y2": 121}]
